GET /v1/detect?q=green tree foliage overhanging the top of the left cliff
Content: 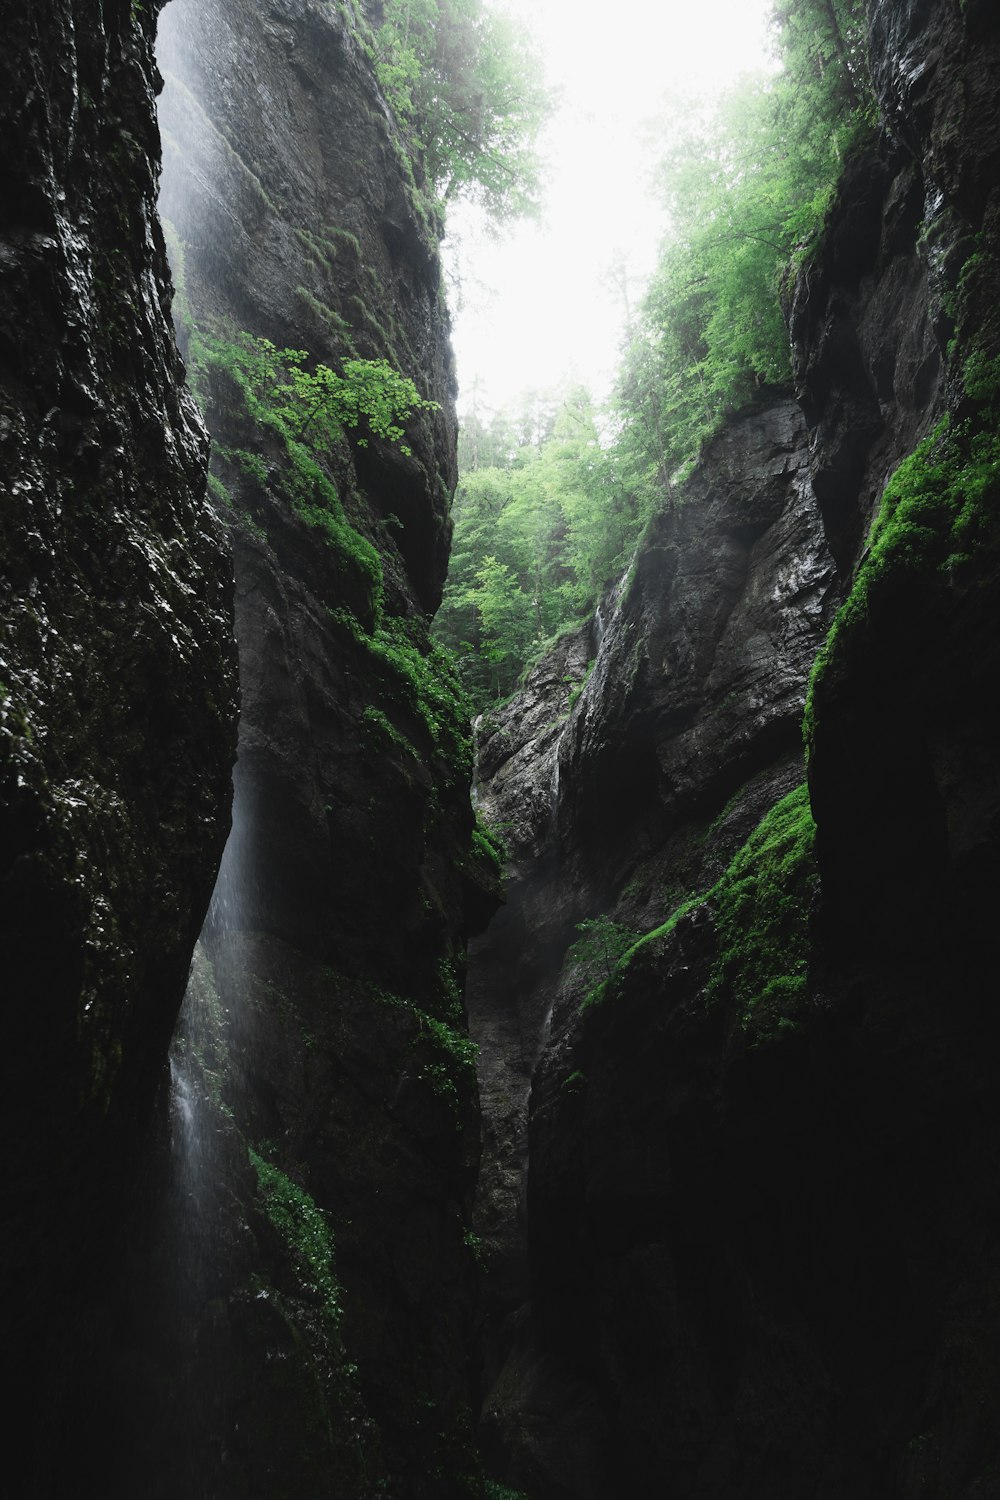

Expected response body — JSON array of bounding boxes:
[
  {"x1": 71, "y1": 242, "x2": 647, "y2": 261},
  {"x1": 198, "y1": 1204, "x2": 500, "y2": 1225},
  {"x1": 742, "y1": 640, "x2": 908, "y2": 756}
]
[{"x1": 373, "y1": 0, "x2": 549, "y2": 219}]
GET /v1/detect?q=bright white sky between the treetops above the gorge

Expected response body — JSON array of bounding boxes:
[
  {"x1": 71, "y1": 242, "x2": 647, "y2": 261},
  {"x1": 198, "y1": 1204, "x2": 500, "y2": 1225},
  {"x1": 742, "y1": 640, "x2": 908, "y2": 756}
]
[{"x1": 451, "y1": 0, "x2": 769, "y2": 411}]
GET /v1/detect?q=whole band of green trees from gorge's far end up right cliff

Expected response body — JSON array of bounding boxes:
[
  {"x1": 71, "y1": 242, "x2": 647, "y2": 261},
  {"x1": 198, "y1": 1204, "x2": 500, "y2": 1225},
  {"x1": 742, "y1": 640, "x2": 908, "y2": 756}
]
[{"x1": 434, "y1": 0, "x2": 873, "y2": 707}]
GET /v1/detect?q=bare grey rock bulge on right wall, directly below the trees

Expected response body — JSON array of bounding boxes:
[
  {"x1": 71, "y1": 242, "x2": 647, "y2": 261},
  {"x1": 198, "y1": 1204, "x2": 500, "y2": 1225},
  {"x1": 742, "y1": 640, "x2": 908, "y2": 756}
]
[{"x1": 559, "y1": 401, "x2": 834, "y2": 896}]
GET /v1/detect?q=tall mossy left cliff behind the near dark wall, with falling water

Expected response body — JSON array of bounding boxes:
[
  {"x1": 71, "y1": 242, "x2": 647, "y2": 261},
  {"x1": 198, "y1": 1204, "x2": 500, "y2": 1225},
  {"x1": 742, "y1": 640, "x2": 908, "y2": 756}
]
[{"x1": 132, "y1": 0, "x2": 495, "y2": 1500}]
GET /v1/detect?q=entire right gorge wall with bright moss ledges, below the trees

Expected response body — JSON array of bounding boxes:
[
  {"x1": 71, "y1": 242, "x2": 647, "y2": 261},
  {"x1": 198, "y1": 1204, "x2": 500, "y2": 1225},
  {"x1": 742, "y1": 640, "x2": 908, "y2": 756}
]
[{"x1": 471, "y1": 0, "x2": 1000, "y2": 1500}]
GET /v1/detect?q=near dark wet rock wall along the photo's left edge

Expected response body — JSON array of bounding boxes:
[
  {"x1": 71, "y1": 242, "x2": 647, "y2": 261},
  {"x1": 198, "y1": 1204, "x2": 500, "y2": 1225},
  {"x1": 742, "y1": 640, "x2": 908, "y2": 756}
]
[{"x1": 0, "y1": 0, "x2": 235, "y2": 1476}]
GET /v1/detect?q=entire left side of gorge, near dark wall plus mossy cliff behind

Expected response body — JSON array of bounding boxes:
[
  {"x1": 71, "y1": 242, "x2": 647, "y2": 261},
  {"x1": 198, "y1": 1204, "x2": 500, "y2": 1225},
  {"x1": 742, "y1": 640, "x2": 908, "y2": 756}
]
[{"x1": 0, "y1": 0, "x2": 496, "y2": 1500}]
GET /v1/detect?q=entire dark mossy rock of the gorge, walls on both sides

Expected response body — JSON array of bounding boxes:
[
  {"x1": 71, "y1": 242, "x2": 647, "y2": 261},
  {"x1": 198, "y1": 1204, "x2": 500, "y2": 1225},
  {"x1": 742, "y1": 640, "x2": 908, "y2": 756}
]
[{"x1": 0, "y1": 0, "x2": 1000, "y2": 1500}]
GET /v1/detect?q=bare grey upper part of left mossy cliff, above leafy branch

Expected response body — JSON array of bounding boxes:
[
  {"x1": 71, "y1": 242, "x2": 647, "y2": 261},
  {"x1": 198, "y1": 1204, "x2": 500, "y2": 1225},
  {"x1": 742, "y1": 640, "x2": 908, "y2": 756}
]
[{"x1": 157, "y1": 0, "x2": 456, "y2": 611}]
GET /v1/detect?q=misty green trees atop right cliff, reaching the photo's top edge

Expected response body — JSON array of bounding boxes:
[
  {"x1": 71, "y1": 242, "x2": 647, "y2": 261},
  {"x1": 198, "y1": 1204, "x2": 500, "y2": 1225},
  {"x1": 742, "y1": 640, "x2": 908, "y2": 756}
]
[{"x1": 621, "y1": 0, "x2": 871, "y2": 495}]
